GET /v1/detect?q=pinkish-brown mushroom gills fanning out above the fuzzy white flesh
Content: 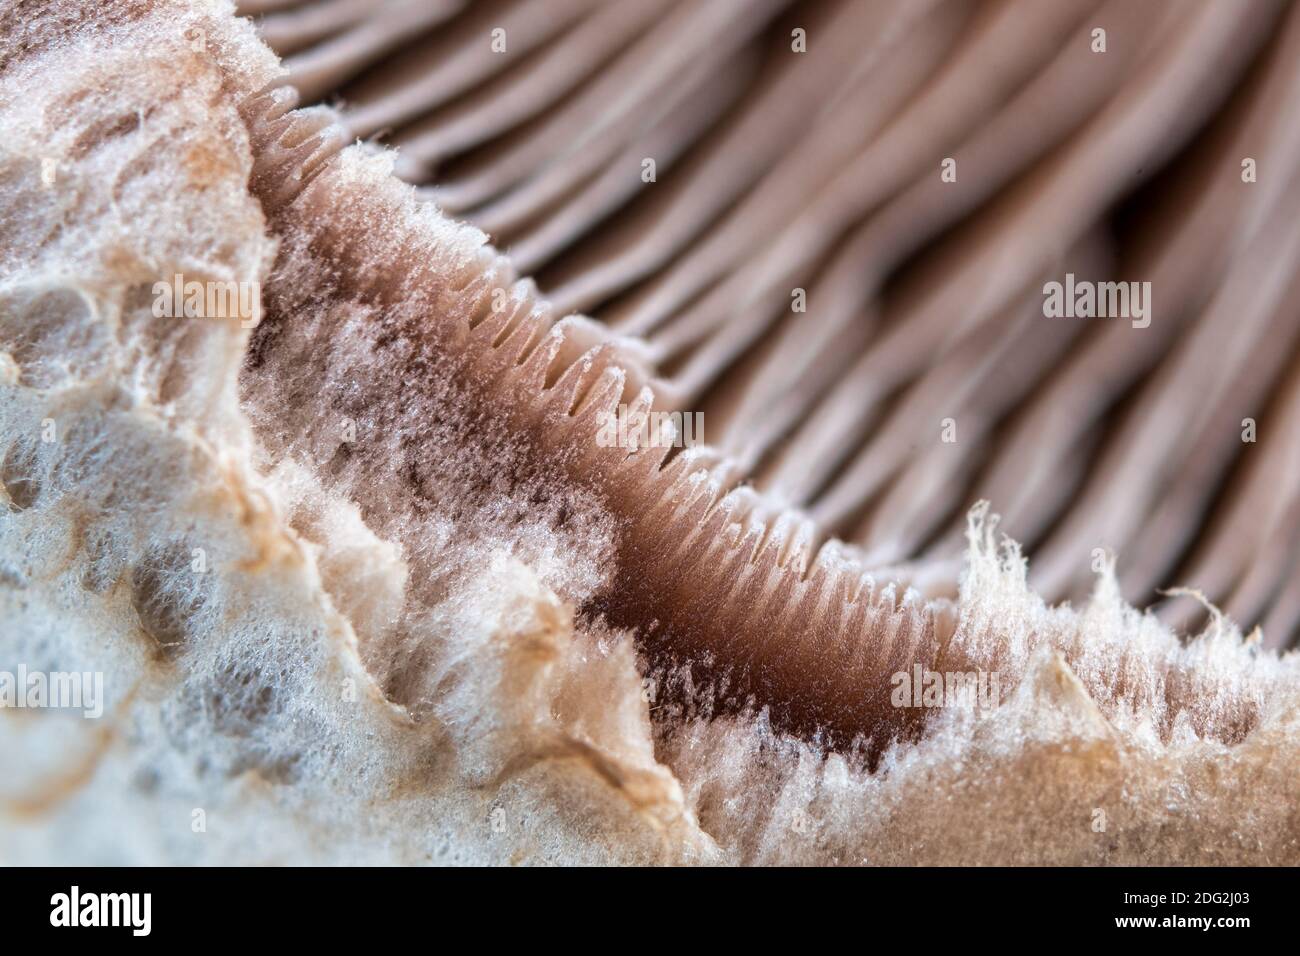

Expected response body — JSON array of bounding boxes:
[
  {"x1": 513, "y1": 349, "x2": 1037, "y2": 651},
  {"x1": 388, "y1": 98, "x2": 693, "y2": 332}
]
[{"x1": 236, "y1": 0, "x2": 1300, "y2": 749}]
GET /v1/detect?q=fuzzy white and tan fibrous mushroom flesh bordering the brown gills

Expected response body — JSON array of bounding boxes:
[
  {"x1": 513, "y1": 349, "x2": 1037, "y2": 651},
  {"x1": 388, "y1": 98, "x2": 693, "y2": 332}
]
[{"x1": 0, "y1": 3, "x2": 1300, "y2": 864}]
